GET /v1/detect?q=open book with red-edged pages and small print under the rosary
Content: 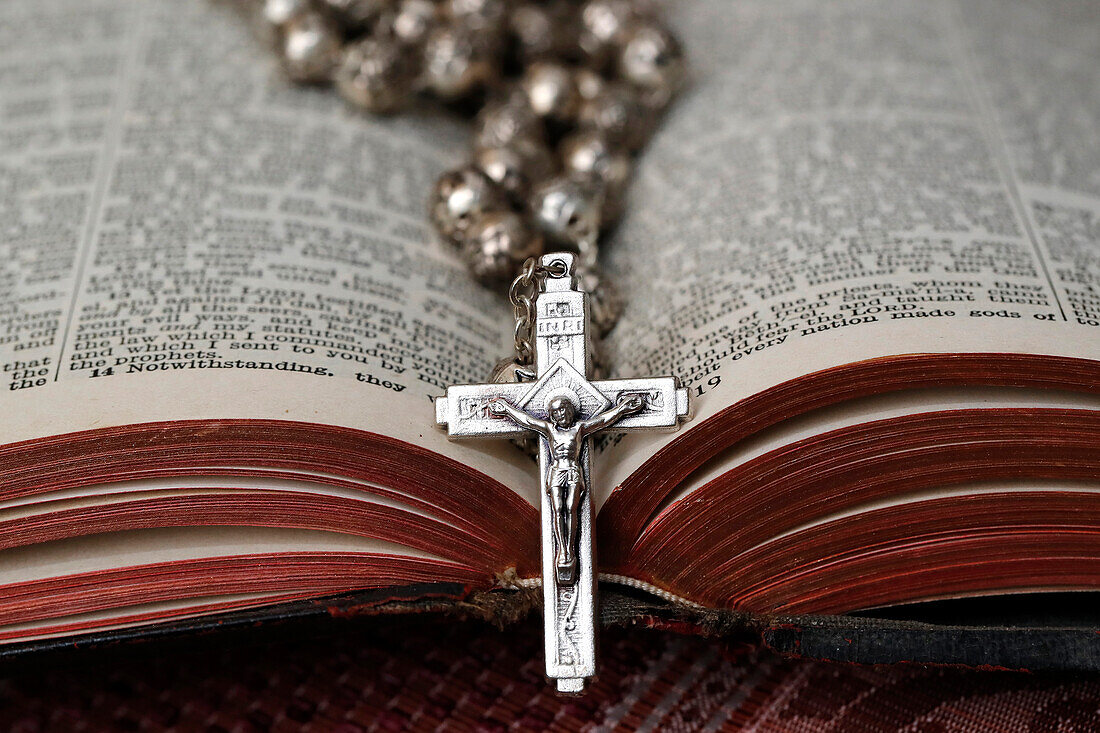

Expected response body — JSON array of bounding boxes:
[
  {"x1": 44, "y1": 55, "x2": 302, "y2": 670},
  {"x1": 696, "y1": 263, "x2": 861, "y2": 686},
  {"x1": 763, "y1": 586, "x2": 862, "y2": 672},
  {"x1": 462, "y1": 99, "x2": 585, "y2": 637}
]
[{"x1": 0, "y1": 0, "x2": 1100, "y2": 661}]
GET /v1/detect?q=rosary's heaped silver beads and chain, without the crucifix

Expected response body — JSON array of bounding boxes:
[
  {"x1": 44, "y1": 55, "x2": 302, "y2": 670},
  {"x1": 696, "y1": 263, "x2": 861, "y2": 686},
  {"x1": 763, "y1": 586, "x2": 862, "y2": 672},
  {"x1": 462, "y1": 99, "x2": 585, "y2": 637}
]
[{"x1": 245, "y1": 0, "x2": 686, "y2": 367}]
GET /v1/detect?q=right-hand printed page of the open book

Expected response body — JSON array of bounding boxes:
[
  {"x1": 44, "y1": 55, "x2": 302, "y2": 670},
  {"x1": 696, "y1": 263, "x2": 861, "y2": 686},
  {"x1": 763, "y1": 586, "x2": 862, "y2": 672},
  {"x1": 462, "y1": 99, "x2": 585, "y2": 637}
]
[{"x1": 603, "y1": 0, "x2": 1100, "y2": 485}]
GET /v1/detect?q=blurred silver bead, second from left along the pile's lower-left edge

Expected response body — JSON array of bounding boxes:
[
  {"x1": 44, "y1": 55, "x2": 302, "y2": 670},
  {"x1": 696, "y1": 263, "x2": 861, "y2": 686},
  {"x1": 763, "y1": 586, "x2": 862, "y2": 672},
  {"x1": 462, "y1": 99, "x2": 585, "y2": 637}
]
[{"x1": 334, "y1": 39, "x2": 414, "y2": 112}]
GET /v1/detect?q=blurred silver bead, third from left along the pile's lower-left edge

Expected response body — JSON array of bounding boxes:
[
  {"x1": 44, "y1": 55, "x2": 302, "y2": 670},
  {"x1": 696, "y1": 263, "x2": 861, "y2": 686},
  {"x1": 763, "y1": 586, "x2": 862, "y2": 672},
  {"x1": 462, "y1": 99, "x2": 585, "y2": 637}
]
[{"x1": 421, "y1": 26, "x2": 497, "y2": 101}]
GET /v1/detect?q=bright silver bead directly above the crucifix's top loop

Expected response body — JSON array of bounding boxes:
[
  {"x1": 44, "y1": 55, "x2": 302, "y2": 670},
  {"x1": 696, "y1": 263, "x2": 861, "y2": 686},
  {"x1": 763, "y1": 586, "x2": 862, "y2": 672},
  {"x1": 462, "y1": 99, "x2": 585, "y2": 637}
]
[{"x1": 530, "y1": 176, "x2": 603, "y2": 249}]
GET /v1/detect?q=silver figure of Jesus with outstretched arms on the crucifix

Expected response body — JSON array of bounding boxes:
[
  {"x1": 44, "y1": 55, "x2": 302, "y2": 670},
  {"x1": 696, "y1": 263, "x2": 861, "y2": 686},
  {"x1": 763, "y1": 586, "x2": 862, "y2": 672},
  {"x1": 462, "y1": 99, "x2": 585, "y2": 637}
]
[{"x1": 488, "y1": 395, "x2": 646, "y2": 586}]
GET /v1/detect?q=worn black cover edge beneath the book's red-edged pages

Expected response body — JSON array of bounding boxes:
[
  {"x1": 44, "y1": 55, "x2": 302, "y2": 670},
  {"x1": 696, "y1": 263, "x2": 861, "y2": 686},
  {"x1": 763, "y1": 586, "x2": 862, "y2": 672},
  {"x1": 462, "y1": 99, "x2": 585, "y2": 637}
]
[{"x1": 0, "y1": 583, "x2": 1100, "y2": 671}]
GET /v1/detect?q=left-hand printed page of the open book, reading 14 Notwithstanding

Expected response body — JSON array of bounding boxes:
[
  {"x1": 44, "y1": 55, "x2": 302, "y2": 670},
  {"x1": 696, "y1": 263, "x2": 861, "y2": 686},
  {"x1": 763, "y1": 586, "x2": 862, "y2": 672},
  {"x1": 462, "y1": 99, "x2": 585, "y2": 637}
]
[{"x1": 0, "y1": 0, "x2": 537, "y2": 499}]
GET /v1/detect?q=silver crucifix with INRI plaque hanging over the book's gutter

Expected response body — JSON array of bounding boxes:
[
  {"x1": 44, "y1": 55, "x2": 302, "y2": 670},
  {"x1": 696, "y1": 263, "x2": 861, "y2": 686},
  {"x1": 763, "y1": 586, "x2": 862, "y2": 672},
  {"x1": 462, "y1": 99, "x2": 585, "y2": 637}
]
[{"x1": 436, "y1": 253, "x2": 690, "y2": 693}]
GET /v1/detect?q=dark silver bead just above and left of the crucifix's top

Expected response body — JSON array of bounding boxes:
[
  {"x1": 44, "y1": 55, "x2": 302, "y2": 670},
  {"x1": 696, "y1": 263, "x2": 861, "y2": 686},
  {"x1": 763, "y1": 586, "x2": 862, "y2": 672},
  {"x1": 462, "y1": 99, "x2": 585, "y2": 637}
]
[{"x1": 462, "y1": 211, "x2": 542, "y2": 284}]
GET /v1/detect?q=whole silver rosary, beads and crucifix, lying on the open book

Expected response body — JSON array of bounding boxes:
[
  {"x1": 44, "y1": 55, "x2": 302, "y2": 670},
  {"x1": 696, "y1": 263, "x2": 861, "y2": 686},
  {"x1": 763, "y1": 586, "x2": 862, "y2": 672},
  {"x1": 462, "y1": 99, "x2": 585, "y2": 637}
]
[{"x1": 253, "y1": 0, "x2": 690, "y2": 693}]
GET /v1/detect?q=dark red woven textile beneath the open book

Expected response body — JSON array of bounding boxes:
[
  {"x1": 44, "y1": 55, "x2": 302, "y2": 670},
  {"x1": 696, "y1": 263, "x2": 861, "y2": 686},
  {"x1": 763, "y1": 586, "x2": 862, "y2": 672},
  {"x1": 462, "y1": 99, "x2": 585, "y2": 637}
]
[{"x1": 0, "y1": 619, "x2": 1100, "y2": 733}]
